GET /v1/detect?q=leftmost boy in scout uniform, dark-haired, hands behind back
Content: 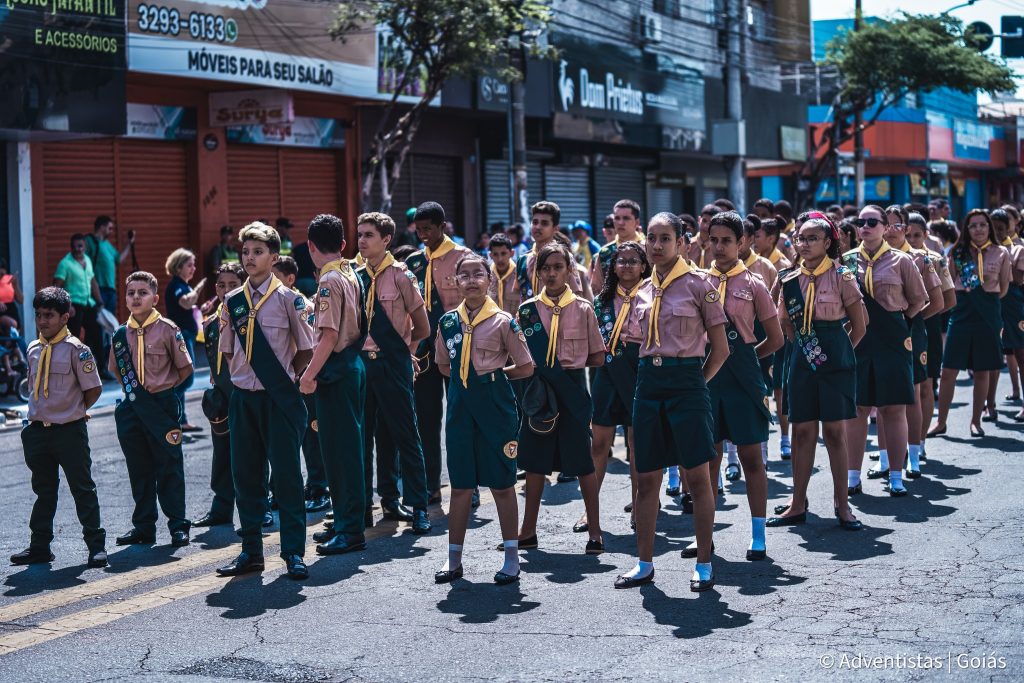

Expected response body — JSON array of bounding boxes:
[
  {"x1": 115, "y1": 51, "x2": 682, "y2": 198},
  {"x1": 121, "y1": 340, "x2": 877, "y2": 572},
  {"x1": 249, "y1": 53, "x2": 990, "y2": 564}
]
[{"x1": 10, "y1": 287, "x2": 106, "y2": 567}]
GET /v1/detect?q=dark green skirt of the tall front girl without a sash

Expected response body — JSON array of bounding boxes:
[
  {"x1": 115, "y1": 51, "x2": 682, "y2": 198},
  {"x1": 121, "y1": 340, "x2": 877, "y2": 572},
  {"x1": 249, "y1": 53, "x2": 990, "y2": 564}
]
[{"x1": 633, "y1": 358, "x2": 715, "y2": 472}]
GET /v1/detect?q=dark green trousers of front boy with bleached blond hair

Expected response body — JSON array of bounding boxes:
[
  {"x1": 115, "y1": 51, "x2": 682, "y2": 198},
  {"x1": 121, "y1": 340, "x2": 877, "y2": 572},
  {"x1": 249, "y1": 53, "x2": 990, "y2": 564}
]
[{"x1": 228, "y1": 387, "x2": 306, "y2": 556}]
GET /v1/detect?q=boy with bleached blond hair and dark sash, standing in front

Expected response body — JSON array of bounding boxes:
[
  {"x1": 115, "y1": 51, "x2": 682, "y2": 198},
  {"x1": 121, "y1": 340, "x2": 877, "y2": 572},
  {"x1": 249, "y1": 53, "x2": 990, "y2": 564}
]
[{"x1": 217, "y1": 221, "x2": 313, "y2": 580}]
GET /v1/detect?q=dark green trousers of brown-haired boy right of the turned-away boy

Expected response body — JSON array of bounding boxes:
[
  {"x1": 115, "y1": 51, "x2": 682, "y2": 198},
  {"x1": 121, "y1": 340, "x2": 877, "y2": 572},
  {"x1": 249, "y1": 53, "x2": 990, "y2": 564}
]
[{"x1": 362, "y1": 353, "x2": 428, "y2": 509}]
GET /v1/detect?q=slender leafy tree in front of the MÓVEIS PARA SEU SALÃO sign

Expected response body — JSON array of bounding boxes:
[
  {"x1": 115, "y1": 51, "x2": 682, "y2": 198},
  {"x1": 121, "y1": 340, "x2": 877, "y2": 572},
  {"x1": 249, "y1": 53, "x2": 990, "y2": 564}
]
[{"x1": 331, "y1": 0, "x2": 553, "y2": 212}]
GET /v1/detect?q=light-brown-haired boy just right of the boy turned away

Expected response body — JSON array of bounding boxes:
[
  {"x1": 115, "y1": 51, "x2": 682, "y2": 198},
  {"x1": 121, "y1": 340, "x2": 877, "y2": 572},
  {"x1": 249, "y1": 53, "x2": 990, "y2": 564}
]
[{"x1": 356, "y1": 212, "x2": 432, "y2": 533}]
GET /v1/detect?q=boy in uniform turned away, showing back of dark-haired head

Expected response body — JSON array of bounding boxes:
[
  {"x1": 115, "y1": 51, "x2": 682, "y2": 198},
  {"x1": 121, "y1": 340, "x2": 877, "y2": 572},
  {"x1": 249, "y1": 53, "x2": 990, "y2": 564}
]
[{"x1": 299, "y1": 214, "x2": 367, "y2": 555}]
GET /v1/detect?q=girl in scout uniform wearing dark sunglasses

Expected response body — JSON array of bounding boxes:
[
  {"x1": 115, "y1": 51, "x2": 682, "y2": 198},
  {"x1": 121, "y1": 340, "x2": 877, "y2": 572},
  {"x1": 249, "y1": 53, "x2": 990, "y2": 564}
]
[{"x1": 839, "y1": 205, "x2": 928, "y2": 497}]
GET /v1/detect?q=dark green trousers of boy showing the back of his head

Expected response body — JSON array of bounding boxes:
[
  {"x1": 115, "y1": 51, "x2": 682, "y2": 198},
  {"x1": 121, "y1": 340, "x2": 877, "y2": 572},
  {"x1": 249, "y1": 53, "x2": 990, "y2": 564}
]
[{"x1": 313, "y1": 353, "x2": 367, "y2": 533}]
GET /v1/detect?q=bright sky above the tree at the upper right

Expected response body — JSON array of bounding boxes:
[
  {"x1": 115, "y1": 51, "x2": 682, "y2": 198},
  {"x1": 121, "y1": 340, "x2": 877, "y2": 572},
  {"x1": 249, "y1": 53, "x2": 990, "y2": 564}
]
[{"x1": 811, "y1": 0, "x2": 1024, "y2": 102}]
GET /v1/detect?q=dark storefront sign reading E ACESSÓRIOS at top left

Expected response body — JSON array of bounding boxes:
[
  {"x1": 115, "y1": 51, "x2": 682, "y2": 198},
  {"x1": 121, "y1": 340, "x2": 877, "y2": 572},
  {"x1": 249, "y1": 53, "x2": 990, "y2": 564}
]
[{"x1": 0, "y1": 0, "x2": 125, "y2": 134}]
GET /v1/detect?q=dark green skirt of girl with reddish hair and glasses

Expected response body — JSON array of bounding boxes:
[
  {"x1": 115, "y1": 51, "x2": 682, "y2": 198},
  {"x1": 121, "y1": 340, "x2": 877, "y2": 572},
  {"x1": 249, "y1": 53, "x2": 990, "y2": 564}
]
[{"x1": 785, "y1": 321, "x2": 857, "y2": 422}]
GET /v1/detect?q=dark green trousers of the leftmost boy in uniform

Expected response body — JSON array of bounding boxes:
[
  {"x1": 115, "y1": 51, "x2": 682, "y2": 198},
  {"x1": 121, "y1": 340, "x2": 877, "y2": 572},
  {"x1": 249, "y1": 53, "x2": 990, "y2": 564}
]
[{"x1": 22, "y1": 420, "x2": 106, "y2": 552}]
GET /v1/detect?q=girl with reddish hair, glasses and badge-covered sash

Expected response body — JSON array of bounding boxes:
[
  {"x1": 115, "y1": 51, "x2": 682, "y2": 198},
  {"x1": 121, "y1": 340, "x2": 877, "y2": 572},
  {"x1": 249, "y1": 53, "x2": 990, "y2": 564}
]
[{"x1": 768, "y1": 212, "x2": 866, "y2": 530}]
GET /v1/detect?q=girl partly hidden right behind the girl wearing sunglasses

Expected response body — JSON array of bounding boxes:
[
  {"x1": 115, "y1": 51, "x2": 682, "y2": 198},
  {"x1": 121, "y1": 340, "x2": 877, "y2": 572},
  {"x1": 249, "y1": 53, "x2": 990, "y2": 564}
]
[{"x1": 867, "y1": 204, "x2": 944, "y2": 479}]
